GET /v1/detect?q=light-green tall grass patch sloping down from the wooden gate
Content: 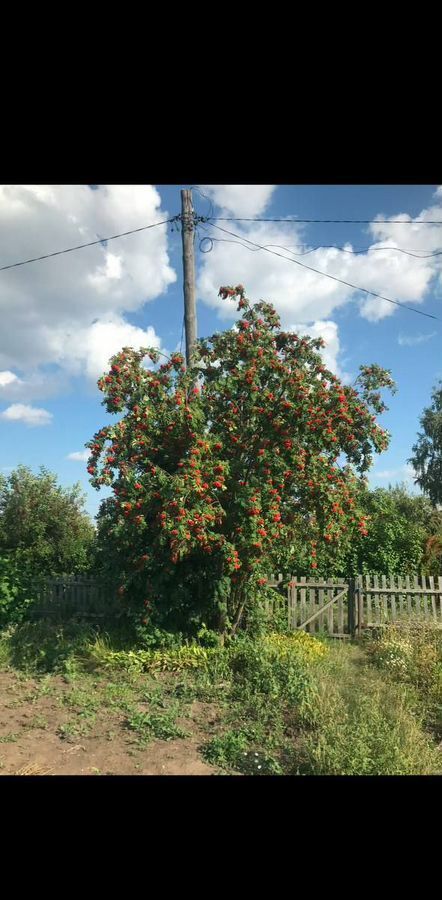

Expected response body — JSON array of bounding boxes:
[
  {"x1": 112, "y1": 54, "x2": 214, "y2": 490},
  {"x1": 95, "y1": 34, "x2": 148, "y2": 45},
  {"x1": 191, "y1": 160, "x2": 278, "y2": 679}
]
[{"x1": 289, "y1": 647, "x2": 442, "y2": 775}]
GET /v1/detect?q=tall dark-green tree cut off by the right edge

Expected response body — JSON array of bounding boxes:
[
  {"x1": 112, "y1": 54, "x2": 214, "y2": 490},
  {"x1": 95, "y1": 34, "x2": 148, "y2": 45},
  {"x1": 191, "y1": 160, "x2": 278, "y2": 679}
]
[{"x1": 409, "y1": 382, "x2": 442, "y2": 507}]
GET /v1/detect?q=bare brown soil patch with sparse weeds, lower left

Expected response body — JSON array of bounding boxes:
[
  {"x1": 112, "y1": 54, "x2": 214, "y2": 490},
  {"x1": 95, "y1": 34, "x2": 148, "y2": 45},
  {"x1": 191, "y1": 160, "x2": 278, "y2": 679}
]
[{"x1": 0, "y1": 671, "x2": 217, "y2": 775}]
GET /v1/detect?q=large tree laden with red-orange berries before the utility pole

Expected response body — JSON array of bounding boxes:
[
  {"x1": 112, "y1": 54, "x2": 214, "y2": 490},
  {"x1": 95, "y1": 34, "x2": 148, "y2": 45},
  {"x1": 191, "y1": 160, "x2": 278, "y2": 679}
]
[{"x1": 88, "y1": 285, "x2": 394, "y2": 633}]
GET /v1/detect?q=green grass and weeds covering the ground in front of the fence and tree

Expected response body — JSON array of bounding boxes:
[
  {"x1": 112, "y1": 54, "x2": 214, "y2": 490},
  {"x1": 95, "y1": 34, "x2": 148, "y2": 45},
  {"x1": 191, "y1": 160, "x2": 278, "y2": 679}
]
[{"x1": 0, "y1": 622, "x2": 442, "y2": 775}]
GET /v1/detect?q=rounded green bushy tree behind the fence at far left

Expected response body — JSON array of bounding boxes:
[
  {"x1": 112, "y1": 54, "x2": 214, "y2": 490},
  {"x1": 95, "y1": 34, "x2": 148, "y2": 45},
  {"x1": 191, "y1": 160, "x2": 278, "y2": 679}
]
[{"x1": 0, "y1": 466, "x2": 95, "y2": 624}]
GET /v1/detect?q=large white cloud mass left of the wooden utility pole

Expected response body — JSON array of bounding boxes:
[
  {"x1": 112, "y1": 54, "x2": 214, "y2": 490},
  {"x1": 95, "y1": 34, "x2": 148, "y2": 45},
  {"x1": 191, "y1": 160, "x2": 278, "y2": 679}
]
[{"x1": 0, "y1": 185, "x2": 176, "y2": 384}]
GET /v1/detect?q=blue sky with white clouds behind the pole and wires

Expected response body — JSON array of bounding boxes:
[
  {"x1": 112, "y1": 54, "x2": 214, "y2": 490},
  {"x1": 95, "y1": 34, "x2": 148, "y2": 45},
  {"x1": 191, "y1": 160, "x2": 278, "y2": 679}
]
[{"x1": 0, "y1": 185, "x2": 442, "y2": 515}]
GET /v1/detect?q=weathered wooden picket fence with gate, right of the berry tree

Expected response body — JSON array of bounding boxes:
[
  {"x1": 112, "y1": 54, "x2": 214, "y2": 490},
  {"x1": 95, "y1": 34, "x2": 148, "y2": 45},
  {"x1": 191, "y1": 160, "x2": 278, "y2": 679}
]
[{"x1": 266, "y1": 575, "x2": 442, "y2": 639}]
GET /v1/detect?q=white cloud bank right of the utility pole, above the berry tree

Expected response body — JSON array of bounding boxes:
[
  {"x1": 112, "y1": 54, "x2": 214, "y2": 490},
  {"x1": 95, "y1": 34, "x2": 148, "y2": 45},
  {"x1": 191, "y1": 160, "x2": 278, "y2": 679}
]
[{"x1": 198, "y1": 186, "x2": 442, "y2": 327}]
